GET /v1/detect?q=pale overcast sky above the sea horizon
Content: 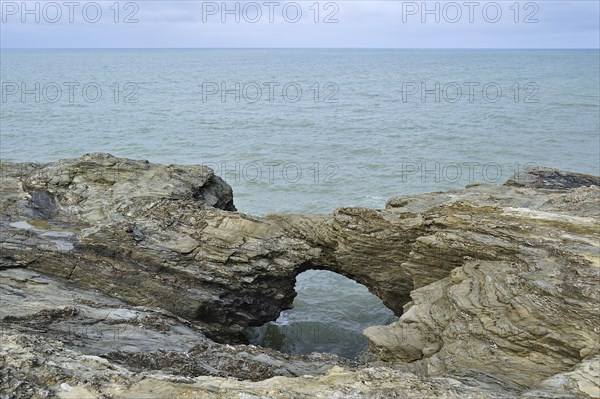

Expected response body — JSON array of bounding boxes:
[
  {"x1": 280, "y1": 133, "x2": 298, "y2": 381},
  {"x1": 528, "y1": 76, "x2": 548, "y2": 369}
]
[{"x1": 0, "y1": 0, "x2": 600, "y2": 48}]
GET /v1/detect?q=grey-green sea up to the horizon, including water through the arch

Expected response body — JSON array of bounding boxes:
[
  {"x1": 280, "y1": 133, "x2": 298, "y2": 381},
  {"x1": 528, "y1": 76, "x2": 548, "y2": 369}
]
[{"x1": 0, "y1": 49, "x2": 600, "y2": 358}]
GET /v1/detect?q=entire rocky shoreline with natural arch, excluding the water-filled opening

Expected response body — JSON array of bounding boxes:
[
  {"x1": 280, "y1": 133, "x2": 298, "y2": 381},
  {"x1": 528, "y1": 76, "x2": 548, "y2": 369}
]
[{"x1": 0, "y1": 153, "x2": 600, "y2": 398}]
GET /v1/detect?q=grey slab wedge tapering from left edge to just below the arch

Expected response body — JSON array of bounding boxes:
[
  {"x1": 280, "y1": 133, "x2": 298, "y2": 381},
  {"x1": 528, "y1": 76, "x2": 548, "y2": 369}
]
[{"x1": 0, "y1": 269, "x2": 356, "y2": 380}]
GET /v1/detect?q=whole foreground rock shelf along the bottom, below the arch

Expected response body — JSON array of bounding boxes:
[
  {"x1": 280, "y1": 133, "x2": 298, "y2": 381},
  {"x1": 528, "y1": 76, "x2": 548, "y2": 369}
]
[{"x1": 0, "y1": 268, "x2": 510, "y2": 399}]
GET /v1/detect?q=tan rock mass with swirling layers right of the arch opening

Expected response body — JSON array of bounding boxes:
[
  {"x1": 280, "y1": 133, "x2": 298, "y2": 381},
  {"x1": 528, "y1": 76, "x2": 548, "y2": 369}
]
[{"x1": 366, "y1": 186, "x2": 600, "y2": 386}]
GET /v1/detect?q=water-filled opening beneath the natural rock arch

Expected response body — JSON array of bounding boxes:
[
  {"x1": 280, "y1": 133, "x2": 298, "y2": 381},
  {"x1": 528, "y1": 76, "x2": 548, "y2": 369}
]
[{"x1": 246, "y1": 269, "x2": 398, "y2": 359}]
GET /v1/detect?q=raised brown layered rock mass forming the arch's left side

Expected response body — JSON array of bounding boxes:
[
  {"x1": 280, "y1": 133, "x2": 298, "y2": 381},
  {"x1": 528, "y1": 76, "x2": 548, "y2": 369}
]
[{"x1": 0, "y1": 154, "x2": 318, "y2": 342}]
